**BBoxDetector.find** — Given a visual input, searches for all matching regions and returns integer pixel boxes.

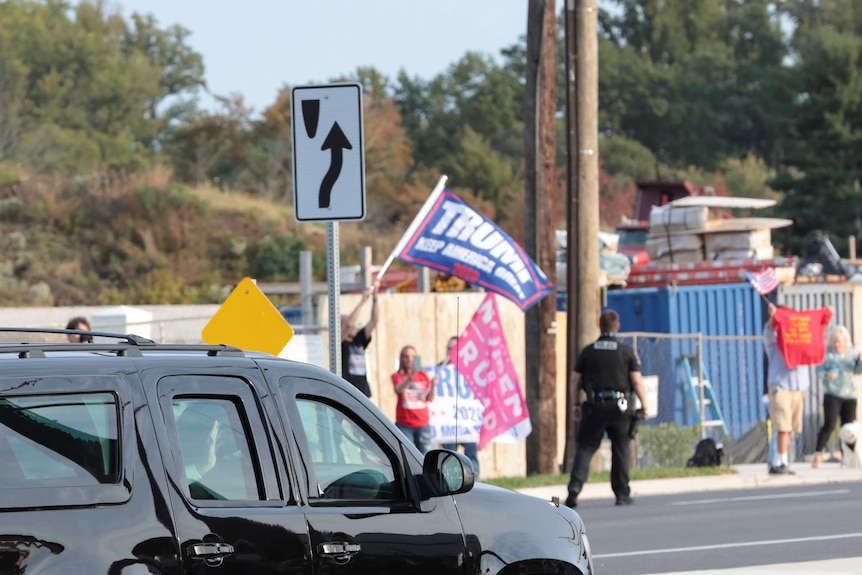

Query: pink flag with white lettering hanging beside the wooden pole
[449,293,531,449]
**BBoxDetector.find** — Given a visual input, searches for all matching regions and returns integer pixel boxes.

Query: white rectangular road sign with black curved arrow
[290,83,365,222]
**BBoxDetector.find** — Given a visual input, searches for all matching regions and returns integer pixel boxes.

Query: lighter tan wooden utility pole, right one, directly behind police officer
[564,0,600,470]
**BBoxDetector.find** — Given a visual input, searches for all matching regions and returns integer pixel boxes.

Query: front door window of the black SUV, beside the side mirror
[296,398,401,500]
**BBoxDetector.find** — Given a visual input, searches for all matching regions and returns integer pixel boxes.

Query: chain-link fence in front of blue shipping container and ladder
[619,332,822,468]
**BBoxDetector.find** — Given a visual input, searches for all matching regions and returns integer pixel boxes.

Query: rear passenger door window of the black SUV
[171,396,260,500]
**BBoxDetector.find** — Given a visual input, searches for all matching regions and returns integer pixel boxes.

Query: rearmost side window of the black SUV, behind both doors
[0,393,120,487]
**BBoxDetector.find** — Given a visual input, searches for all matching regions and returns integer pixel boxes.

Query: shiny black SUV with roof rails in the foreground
[0,328,593,575]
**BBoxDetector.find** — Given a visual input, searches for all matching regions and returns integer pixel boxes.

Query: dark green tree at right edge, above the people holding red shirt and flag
[774,24,862,254]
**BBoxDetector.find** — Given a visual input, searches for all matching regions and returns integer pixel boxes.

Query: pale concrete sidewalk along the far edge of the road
[518,461,862,502]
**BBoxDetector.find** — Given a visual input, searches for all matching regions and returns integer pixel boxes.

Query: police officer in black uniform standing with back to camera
[566,309,647,508]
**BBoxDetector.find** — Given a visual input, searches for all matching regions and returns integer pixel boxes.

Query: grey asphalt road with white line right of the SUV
[578,482,862,575]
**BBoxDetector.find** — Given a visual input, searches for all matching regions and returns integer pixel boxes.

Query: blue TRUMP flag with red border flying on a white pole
[380,177,552,311]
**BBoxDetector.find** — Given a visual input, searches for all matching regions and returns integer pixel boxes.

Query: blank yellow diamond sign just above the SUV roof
[201,278,293,355]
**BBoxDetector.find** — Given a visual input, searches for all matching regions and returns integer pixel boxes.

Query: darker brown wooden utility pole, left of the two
[524,0,558,474]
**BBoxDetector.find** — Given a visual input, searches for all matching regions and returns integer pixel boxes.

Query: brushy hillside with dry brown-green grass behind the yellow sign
[0,169,398,306]
